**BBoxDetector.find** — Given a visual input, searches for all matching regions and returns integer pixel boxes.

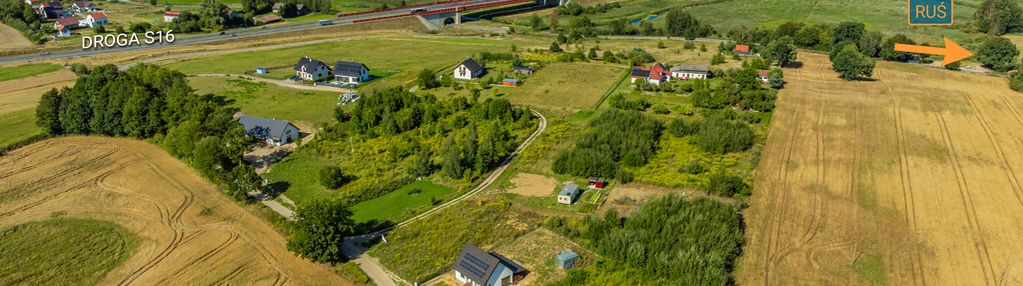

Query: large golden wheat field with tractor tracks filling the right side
[738,53,1023,285]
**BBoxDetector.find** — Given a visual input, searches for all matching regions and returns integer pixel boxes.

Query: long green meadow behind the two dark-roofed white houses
[168,38,531,88]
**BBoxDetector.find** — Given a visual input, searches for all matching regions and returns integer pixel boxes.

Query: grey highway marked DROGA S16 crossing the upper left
[0,0,527,63]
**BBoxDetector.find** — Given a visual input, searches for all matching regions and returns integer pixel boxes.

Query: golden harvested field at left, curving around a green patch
[0,137,350,285]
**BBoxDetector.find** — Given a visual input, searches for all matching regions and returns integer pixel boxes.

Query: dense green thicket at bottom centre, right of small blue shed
[559,195,743,285]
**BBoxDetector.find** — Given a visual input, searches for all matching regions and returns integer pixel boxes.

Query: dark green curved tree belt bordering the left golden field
[36,64,261,200]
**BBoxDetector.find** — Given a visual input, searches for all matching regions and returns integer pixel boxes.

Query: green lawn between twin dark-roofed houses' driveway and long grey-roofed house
[188,77,340,127]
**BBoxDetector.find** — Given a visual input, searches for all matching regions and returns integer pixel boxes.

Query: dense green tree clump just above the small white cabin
[552,108,662,182]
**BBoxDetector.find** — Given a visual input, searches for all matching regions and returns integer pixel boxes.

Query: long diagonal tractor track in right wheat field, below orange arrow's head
[935,113,994,285]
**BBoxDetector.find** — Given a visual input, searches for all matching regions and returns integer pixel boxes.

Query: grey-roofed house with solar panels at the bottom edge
[452,243,526,286]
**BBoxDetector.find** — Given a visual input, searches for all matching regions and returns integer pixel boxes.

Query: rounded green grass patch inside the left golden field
[0,219,138,285]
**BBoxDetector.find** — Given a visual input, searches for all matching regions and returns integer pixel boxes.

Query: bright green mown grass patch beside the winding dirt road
[352,181,454,223]
